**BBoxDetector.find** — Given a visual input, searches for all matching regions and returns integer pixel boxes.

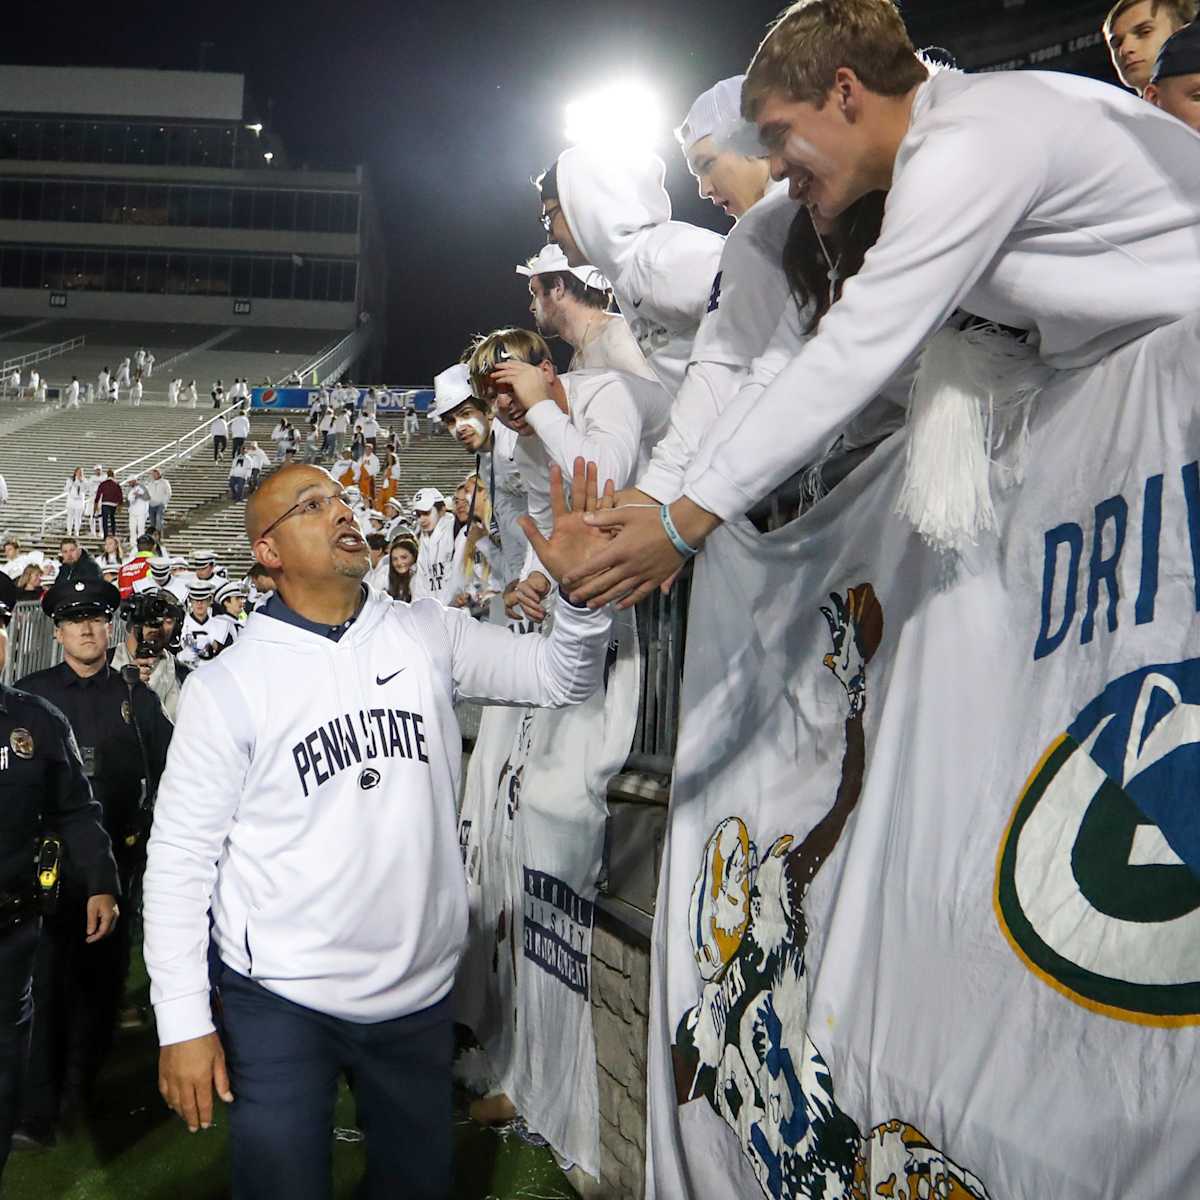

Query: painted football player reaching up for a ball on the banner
[671,583,988,1200]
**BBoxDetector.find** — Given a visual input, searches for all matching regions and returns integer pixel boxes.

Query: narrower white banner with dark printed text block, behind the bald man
[456,613,640,1176]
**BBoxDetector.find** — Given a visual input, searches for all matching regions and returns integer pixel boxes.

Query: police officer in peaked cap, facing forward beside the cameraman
[18,580,173,1142]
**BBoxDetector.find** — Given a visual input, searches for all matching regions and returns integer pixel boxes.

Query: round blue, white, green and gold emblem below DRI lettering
[995,659,1200,1026]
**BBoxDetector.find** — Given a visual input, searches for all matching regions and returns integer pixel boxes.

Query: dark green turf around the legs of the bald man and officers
[0,956,576,1200]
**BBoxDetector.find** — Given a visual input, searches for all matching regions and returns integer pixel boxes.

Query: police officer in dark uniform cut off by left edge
[0,575,118,1174]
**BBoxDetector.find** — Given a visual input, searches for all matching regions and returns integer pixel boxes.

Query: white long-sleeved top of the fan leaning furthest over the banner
[684,71,1200,520]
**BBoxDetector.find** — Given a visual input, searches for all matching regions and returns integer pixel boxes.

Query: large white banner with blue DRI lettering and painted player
[647,319,1200,1200]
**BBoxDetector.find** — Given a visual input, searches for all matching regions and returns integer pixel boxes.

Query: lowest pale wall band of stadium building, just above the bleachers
[0,285,355,331]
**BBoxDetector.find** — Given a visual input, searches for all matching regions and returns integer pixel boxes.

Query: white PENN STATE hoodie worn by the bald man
[145,588,610,1045]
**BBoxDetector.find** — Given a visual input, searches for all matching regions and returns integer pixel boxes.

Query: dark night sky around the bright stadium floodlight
[11,0,1113,383]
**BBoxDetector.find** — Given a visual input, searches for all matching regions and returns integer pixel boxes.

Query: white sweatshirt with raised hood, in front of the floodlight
[558,146,725,396]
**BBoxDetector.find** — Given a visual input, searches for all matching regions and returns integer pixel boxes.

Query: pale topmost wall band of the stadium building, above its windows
[0,66,246,121]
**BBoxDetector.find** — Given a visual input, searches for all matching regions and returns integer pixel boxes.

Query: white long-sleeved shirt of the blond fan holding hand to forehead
[516,371,671,575]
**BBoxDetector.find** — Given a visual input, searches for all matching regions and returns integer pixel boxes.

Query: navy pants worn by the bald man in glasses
[215,962,454,1200]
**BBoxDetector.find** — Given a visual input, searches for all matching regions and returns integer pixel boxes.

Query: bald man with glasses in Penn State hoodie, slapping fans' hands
[144,460,610,1200]
